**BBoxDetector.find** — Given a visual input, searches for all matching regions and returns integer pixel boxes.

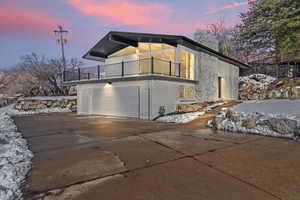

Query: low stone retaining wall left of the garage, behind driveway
[15,96,77,111]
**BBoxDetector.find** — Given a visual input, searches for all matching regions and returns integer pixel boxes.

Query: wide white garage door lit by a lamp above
[89,86,140,118]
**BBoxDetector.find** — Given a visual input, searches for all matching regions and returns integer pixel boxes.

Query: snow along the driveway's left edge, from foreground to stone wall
[0,104,70,200]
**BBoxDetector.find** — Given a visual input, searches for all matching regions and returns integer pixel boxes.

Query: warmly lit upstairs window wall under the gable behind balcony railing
[108,42,196,80]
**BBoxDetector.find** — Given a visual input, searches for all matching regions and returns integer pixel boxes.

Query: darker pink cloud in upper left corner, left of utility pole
[0,5,65,36]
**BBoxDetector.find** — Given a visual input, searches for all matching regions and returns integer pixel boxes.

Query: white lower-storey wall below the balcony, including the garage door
[77,80,195,119]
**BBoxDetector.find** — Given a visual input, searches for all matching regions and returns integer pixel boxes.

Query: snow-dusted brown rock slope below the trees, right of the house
[239,74,300,100]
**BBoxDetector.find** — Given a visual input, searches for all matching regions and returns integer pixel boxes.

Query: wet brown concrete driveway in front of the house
[15,113,300,200]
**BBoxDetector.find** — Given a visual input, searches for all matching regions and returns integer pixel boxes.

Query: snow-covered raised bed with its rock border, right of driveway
[213,99,300,139]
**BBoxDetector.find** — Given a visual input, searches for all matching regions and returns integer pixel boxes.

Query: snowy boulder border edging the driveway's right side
[208,102,300,140]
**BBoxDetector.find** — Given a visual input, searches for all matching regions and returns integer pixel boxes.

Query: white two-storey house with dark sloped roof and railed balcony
[64,32,249,119]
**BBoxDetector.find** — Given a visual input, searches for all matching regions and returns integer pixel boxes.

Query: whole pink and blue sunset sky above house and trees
[0,0,253,68]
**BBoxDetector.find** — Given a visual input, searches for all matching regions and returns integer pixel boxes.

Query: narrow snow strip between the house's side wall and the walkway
[157,102,224,124]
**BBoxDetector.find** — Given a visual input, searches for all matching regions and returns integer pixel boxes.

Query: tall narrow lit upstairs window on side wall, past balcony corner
[180,50,195,80]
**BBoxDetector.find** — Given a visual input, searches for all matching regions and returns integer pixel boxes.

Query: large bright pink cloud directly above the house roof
[66,0,204,33]
